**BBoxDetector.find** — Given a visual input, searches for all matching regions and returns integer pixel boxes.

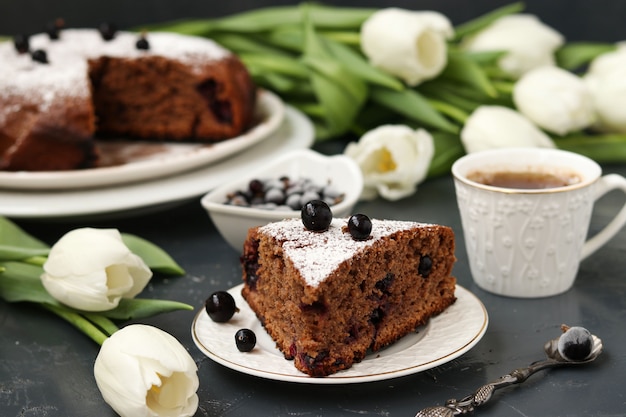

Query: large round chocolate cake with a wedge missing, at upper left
[0,29,256,171]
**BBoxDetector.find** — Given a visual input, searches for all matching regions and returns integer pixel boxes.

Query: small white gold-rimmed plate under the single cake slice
[191,284,489,384]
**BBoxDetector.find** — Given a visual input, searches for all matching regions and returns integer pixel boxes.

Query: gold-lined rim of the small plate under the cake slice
[191,284,489,385]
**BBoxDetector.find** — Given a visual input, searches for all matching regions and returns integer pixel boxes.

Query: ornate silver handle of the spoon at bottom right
[415,359,567,417]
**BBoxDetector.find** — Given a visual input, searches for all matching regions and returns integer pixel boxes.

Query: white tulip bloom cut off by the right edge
[584,47,626,133]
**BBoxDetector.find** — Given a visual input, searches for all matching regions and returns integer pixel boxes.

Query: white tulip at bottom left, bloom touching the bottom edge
[93,324,199,417]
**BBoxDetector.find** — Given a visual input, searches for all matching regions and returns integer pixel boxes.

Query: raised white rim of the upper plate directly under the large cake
[0,89,286,191]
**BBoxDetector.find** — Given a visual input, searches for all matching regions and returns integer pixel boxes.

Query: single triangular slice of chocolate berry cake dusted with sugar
[241,219,456,376]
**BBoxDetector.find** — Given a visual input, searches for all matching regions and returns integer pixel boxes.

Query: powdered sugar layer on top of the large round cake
[0,29,230,118]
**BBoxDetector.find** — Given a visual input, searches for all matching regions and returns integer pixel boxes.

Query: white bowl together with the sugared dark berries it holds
[201,149,363,251]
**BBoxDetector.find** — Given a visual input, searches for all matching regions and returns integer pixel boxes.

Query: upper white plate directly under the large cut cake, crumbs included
[0,90,285,190]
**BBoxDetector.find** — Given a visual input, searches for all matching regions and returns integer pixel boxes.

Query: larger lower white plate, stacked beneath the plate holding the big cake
[0,106,315,219]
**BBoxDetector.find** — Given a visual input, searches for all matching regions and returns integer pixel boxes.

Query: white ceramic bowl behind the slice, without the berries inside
[200,149,363,251]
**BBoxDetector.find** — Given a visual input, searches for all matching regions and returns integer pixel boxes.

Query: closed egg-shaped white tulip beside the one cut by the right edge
[513,67,594,135]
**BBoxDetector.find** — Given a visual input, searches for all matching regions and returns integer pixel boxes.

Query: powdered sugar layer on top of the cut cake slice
[260,219,430,287]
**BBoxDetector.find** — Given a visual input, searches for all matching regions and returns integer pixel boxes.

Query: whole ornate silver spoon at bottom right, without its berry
[415,326,602,417]
